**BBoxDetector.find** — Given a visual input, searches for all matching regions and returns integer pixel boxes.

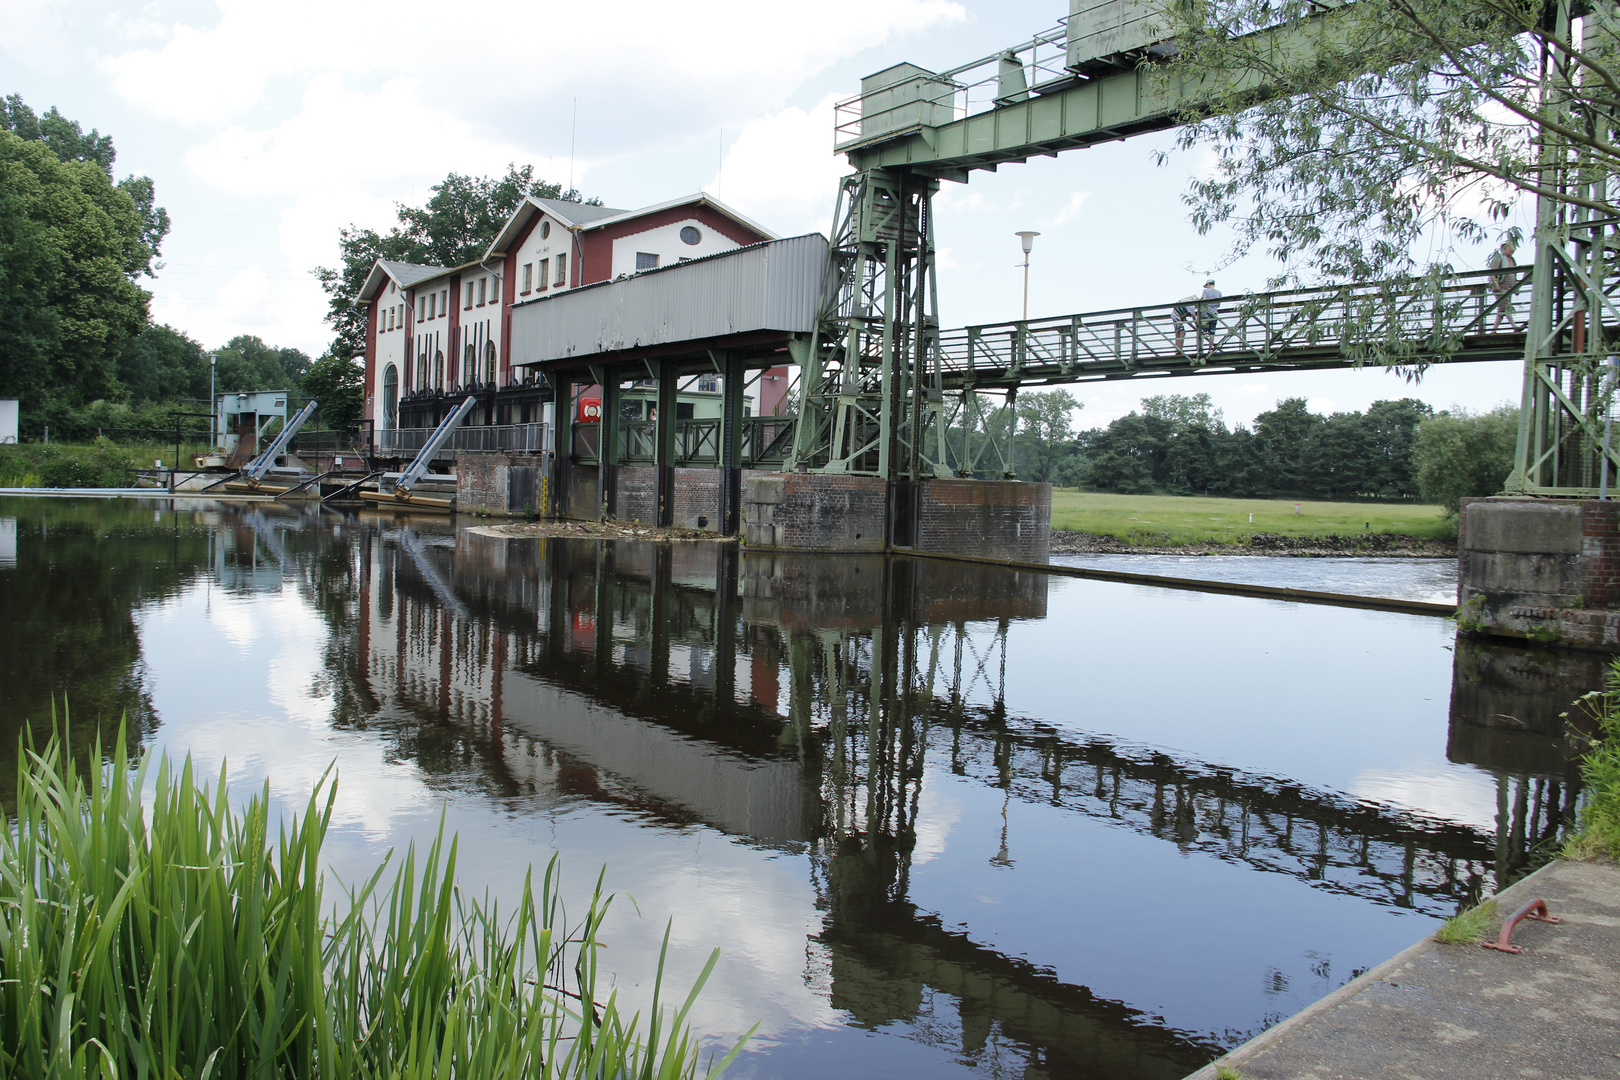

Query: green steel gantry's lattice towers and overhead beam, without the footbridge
[787,0,1620,495]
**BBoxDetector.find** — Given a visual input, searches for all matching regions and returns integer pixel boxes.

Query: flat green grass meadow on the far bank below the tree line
[1051,491,1456,544]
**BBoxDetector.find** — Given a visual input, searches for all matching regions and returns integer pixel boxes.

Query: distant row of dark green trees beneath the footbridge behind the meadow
[978,390,1518,512]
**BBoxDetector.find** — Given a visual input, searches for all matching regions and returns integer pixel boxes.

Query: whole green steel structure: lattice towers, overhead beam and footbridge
[784,0,1620,495]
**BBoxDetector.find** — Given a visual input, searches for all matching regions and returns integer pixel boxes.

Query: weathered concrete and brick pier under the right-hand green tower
[1456,497,1620,651]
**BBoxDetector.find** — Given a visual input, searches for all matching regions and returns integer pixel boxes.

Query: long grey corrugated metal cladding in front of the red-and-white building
[510,233,828,364]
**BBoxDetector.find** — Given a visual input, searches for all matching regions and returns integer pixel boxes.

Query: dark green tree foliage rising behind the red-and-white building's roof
[316,165,601,359]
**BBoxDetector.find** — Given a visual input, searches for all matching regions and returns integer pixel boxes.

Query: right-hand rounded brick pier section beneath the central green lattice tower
[917,479,1051,562]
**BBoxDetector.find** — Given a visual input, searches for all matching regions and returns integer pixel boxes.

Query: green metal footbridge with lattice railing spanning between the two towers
[938,266,1531,387]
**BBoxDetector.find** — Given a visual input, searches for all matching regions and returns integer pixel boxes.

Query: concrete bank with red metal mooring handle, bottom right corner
[1187,861,1620,1080]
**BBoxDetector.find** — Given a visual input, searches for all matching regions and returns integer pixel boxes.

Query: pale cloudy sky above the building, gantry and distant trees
[0,0,1529,427]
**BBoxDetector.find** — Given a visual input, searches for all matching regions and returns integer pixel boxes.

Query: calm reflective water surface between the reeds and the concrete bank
[0,499,1601,1080]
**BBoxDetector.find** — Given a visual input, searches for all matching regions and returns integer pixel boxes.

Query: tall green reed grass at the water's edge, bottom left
[0,725,740,1080]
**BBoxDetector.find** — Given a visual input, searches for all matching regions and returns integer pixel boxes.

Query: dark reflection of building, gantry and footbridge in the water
[335,526,1570,1078]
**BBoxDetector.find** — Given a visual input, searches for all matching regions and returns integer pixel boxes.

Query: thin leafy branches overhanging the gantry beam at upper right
[1165,0,1620,283]
